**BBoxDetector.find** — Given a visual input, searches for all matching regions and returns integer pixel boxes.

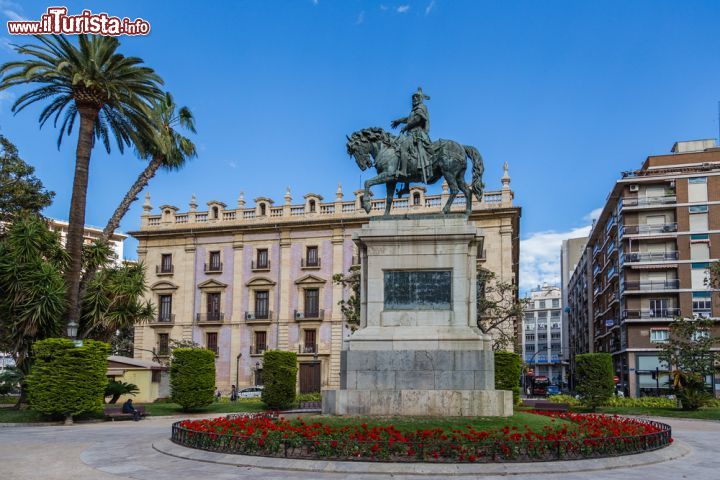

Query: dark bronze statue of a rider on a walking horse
[347,88,484,215]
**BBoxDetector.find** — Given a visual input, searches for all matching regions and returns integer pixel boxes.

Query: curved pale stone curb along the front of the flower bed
[152,439,692,476]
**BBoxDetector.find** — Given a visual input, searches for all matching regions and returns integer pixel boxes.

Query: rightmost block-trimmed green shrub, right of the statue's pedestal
[575,353,615,412]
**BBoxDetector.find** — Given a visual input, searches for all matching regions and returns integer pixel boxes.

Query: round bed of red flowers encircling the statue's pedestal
[172,412,672,462]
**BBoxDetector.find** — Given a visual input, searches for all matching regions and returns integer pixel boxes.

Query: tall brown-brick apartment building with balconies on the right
[568,140,720,397]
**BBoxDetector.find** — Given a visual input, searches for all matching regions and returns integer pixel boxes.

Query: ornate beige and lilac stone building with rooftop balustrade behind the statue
[131,166,520,394]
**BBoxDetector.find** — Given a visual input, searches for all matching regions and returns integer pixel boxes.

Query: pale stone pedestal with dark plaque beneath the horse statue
[323,215,512,416]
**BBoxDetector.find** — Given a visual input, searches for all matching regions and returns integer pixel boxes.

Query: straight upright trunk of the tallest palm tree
[65,107,98,336]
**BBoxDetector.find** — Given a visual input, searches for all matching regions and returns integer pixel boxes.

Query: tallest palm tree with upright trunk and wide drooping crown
[0,35,163,334]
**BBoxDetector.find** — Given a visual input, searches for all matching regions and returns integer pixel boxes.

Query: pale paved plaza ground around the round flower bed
[0,417,720,480]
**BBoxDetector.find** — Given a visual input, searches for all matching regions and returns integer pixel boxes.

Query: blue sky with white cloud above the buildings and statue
[0,0,720,288]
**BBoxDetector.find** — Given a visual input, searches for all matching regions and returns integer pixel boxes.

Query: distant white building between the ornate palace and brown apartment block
[522,285,566,386]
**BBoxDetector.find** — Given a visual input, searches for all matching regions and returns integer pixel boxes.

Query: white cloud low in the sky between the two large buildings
[520,215,600,292]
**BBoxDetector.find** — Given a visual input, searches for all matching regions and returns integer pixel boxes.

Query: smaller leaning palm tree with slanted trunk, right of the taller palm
[103,92,197,242]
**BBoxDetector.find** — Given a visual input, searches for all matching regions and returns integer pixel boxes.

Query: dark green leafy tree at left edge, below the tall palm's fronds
[0,135,55,222]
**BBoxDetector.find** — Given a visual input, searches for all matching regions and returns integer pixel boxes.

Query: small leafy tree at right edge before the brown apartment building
[659,317,718,410]
